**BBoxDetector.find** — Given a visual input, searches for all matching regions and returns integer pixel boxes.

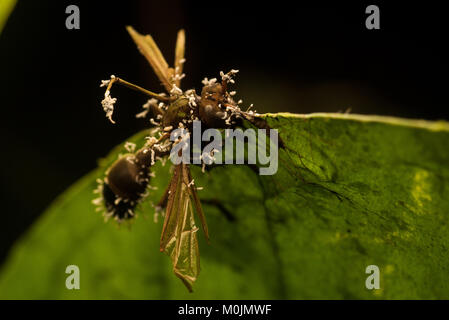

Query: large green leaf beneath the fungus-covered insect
[0,114,449,299]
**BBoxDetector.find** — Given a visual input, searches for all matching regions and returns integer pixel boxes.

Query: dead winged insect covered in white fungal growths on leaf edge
[94,26,265,291]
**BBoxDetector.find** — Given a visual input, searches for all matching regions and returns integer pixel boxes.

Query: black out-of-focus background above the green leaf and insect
[0,0,449,262]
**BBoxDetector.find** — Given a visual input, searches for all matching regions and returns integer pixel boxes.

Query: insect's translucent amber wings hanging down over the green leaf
[160,164,208,291]
